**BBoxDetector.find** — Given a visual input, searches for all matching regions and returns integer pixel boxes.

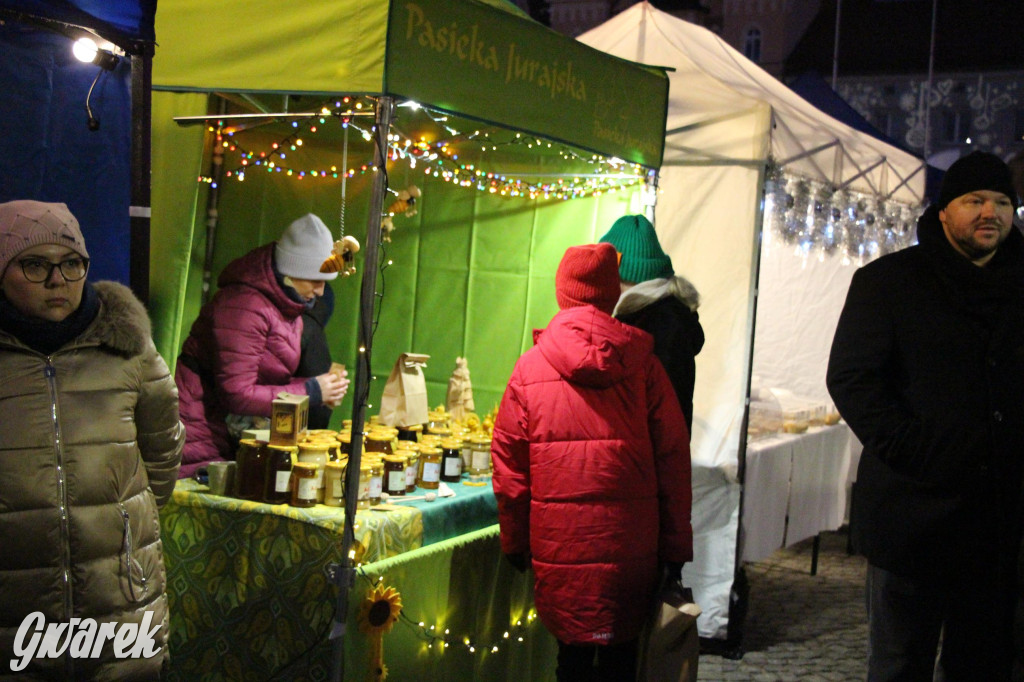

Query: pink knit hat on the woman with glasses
[0,199,89,275]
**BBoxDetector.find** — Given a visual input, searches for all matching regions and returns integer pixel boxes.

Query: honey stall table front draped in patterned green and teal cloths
[161,479,555,680]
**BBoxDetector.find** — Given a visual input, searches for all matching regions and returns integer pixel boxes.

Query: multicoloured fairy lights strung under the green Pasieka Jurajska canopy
[199,97,654,200]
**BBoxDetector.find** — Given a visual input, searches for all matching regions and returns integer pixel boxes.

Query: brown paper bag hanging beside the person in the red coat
[637,580,700,682]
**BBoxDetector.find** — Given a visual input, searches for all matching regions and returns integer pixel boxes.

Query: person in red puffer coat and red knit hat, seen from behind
[492,244,693,681]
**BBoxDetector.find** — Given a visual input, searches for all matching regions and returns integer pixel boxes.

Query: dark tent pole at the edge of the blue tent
[128,49,154,304]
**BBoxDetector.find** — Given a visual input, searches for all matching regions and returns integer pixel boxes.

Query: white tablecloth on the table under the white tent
[740,423,853,561]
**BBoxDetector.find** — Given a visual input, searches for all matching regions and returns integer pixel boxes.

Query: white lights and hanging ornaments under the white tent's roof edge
[764,160,922,266]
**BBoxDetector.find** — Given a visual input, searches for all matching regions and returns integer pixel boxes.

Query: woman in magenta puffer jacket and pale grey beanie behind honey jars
[174,213,348,477]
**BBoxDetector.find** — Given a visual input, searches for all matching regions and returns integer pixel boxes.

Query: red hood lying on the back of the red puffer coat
[534,305,654,387]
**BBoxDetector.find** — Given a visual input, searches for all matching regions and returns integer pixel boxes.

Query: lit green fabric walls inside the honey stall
[146,93,640,426]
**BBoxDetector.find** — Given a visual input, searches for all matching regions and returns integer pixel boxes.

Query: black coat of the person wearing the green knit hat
[615,296,705,433]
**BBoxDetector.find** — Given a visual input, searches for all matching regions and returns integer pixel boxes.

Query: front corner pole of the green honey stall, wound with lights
[328,95,394,682]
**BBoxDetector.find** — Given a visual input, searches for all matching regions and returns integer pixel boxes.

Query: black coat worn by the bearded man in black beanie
[827,207,1024,577]
